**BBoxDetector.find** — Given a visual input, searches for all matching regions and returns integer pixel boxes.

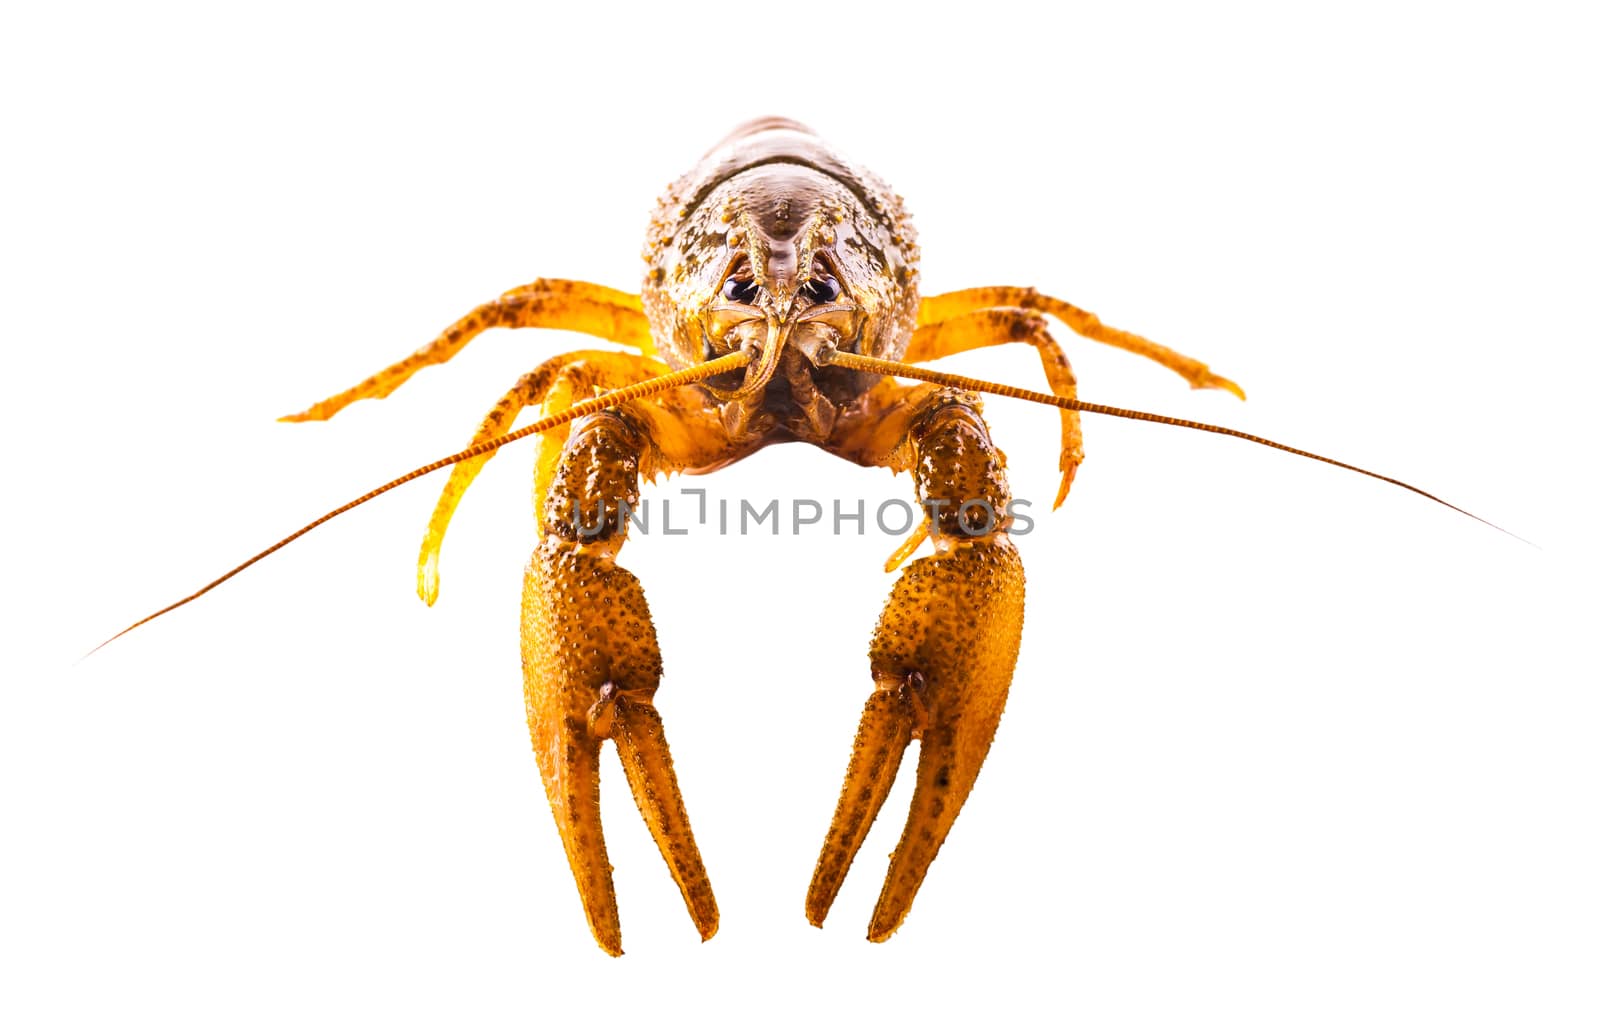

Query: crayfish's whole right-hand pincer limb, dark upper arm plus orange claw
[806,390,1022,942]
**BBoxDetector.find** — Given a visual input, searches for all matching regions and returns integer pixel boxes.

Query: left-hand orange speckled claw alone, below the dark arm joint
[522,537,717,956]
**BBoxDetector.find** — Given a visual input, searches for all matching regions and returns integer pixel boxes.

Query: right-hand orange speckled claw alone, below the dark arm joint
[806,536,1022,942]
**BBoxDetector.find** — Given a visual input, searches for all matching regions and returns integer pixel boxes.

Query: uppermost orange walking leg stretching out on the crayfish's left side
[282,278,654,422]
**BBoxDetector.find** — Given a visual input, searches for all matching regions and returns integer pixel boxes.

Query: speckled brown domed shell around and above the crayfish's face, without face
[642,118,918,369]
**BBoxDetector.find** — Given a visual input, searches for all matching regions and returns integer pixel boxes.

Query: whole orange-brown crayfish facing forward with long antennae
[103,118,1497,955]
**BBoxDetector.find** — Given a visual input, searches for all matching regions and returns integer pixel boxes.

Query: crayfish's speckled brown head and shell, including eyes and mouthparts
[643,118,917,440]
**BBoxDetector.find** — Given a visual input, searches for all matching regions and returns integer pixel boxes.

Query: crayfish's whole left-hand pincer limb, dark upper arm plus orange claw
[522,409,717,955]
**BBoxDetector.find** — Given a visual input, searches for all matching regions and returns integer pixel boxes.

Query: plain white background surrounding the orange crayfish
[0,3,1600,1022]
